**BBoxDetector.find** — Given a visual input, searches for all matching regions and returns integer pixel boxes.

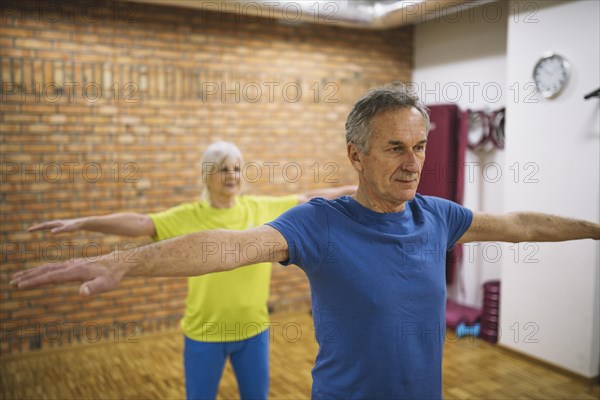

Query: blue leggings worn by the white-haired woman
[183,329,269,400]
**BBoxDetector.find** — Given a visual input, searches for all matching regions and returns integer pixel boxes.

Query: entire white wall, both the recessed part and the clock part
[413,0,600,377]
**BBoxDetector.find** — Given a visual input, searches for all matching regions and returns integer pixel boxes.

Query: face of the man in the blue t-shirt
[348,108,427,210]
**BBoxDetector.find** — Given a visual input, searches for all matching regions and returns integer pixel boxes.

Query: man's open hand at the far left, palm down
[10,253,127,296]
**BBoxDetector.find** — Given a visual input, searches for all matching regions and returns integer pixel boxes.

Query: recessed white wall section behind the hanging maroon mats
[413,1,508,307]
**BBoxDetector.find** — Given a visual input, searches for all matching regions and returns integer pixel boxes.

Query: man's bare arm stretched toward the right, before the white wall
[458,212,600,243]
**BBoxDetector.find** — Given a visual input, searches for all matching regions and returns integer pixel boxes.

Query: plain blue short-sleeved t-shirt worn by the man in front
[268,194,473,399]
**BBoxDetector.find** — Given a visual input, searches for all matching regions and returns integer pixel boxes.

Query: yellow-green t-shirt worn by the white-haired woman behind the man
[150,195,298,342]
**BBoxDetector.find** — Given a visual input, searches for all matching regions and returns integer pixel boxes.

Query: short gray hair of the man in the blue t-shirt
[346,82,429,154]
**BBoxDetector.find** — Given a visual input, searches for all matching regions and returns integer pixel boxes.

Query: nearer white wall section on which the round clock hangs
[500,0,600,377]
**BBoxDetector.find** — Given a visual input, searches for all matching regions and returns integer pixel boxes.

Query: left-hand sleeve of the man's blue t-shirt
[267,199,329,271]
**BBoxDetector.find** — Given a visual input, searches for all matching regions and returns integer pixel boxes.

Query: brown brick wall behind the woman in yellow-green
[0,1,412,354]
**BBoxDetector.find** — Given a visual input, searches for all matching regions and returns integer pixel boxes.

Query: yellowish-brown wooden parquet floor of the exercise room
[0,314,600,399]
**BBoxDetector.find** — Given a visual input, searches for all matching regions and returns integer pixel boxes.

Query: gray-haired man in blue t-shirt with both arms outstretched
[11,84,600,399]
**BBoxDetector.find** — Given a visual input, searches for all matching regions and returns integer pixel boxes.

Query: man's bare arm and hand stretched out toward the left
[11,225,288,296]
